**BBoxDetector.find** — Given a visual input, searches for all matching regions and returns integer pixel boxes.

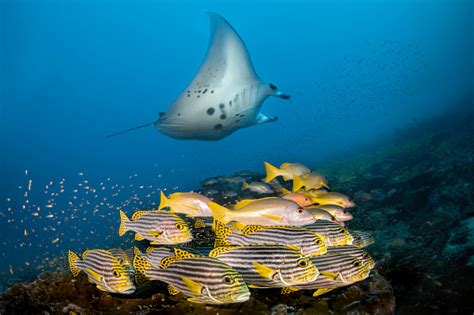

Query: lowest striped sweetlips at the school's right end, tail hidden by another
[282,250,372,296]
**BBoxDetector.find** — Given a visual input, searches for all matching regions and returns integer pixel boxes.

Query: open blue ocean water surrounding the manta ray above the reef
[0,0,474,292]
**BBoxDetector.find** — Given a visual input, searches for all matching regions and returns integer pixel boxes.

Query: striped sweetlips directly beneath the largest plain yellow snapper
[214,221,326,257]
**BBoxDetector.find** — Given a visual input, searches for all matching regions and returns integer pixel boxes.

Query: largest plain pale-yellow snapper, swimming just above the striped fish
[209,197,315,226]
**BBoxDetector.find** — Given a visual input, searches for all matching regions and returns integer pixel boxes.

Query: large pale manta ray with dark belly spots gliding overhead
[108,12,290,141]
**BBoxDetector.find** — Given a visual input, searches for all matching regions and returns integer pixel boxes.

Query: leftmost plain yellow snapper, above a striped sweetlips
[158,191,212,217]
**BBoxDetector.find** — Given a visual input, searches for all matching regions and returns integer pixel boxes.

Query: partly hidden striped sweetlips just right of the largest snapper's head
[304,220,354,246]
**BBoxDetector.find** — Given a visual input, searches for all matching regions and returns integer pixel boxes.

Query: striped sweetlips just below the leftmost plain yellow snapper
[119,210,193,245]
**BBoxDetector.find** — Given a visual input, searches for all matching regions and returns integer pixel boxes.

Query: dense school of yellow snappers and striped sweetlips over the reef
[68,162,375,304]
